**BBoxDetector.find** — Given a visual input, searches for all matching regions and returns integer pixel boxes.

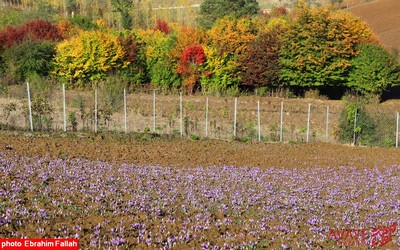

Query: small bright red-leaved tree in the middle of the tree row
[178,44,206,94]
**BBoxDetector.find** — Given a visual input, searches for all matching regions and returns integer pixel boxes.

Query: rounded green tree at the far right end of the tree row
[347,43,400,96]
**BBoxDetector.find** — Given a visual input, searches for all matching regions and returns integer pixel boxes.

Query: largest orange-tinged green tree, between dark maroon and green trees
[280,2,374,95]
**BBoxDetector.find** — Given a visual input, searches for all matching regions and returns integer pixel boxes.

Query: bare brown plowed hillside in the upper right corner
[348,0,400,56]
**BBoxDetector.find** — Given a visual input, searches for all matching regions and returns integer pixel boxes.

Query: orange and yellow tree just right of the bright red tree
[201,16,260,93]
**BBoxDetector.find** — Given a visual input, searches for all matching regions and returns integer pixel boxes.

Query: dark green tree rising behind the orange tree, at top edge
[197,0,260,29]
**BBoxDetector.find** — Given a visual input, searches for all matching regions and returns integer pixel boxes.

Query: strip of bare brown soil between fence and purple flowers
[0,133,400,168]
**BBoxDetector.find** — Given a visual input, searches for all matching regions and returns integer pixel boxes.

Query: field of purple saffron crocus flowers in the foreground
[0,145,400,249]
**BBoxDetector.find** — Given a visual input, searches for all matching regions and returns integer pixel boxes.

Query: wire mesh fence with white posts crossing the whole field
[0,84,399,147]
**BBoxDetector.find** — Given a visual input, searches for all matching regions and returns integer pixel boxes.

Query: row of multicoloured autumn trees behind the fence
[0,0,400,98]
